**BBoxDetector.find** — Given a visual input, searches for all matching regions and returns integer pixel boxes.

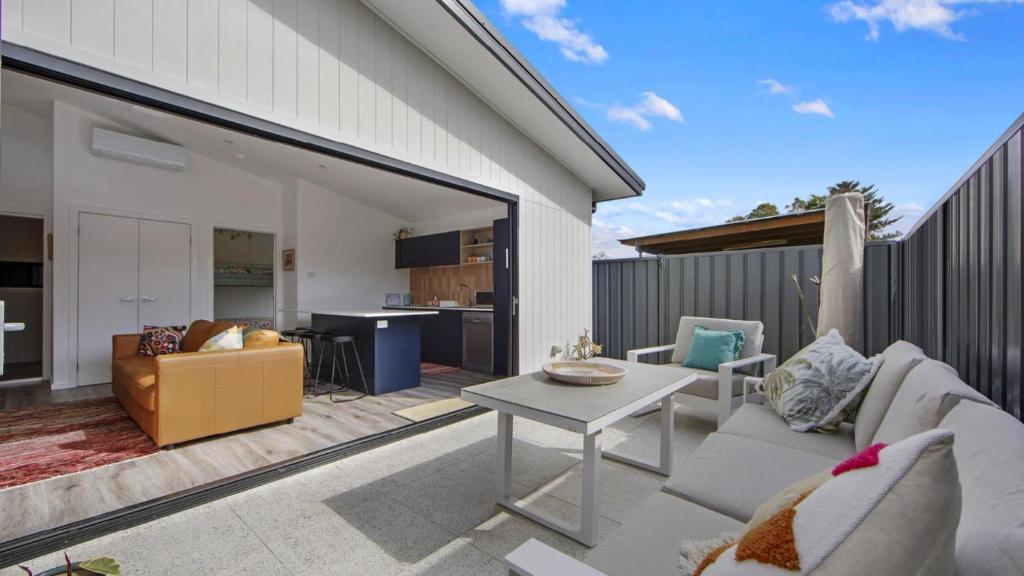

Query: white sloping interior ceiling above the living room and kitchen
[2,71,504,222]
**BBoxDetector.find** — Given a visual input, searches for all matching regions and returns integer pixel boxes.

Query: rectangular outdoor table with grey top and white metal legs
[462,359,697,546]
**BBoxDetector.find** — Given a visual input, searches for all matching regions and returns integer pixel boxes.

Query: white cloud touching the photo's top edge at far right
[828,0,1024,41]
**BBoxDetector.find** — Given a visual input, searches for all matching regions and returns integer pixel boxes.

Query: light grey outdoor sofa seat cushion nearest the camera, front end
[584,492,743,576]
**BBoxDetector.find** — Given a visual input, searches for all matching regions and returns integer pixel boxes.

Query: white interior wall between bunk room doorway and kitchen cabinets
[286,179,410,311]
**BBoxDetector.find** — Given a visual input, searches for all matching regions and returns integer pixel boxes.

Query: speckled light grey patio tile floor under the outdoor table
[0,407,712,576]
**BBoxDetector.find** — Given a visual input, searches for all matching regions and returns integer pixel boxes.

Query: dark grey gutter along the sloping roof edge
[435,0,647,196]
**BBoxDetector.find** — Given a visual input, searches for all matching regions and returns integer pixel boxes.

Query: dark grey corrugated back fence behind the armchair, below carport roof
[593,242,898,361]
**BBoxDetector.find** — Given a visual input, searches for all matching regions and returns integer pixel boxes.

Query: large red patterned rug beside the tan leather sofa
[0,398,160,489]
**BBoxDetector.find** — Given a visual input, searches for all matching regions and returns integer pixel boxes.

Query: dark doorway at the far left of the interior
[0,214,46,385]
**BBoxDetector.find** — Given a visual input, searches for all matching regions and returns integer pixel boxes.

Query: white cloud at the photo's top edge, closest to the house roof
[502,0,608,64]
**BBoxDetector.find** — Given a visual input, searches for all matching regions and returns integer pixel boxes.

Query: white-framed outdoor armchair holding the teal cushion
[626,316,775,426]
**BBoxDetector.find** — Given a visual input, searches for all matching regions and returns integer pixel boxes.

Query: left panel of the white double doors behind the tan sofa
[78,212,139,386]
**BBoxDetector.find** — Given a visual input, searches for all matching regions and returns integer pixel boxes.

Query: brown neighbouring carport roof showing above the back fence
[618,209,825,254]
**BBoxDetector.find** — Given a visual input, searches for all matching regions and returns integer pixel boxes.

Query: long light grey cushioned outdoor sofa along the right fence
[506,341,1024,576]
